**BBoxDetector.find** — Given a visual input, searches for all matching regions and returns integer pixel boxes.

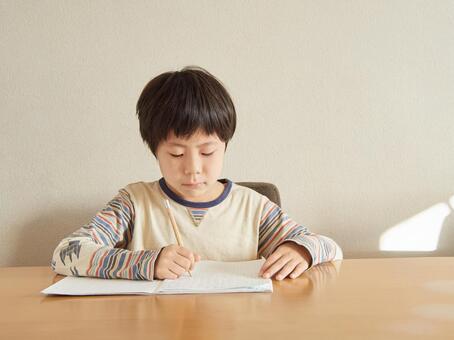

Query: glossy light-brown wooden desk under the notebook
[0,257,454,340]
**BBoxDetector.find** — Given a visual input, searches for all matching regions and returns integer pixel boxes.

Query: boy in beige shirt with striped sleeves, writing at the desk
[51,67,342,280]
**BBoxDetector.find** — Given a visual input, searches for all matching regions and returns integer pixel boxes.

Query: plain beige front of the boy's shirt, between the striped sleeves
[125,181,267,261]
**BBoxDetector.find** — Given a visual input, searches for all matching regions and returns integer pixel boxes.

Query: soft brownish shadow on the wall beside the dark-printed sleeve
[2,209,94,266]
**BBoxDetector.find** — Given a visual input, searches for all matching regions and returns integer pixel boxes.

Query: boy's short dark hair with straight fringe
[136,66,236,156]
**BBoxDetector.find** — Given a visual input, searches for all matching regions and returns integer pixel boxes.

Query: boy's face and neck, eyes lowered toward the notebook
[156,131,225,202]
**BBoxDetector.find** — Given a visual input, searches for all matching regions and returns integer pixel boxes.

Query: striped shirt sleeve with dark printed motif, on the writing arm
[51,189,159,280]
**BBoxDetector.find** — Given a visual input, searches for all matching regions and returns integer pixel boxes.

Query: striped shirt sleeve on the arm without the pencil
[258,200,343,266]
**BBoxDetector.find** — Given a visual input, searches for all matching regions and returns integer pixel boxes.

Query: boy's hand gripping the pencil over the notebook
[154,244,200,280]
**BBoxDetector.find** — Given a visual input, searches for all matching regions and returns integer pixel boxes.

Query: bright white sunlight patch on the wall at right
[380,203,454,251]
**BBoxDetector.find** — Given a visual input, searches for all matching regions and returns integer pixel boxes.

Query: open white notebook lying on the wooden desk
[41,259,273,295]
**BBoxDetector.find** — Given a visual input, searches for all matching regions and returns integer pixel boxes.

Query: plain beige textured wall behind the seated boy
[0,0,454,266]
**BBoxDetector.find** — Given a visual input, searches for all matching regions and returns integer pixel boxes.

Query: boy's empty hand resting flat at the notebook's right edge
[259,242,312,280]
